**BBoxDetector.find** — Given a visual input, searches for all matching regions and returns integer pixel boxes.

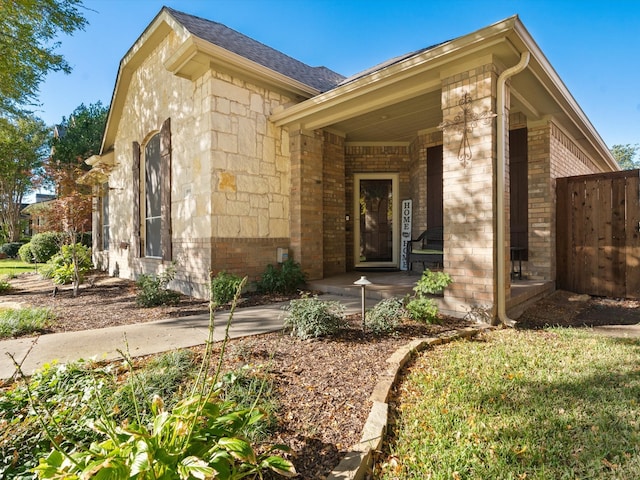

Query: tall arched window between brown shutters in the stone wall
[144,134,162,257]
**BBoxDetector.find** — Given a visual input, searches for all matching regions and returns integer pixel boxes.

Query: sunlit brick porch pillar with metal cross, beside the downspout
[442,64,500,316]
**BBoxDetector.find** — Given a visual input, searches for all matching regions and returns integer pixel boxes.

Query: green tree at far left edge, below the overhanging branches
[0,116,49,242]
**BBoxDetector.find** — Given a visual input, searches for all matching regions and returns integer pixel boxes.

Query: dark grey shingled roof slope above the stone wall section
[163,7,345,92]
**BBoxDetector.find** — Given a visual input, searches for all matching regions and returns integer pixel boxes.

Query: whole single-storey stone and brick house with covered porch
[86,8,618,317]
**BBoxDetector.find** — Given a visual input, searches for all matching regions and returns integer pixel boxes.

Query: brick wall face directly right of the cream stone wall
[289,130,323,280]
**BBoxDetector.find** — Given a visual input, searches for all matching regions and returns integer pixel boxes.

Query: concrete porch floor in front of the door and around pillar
[308,271,555,319]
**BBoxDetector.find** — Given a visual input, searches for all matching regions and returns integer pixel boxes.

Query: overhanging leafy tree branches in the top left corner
[0,0,87,115]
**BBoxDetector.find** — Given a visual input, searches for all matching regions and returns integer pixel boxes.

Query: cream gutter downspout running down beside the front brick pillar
[496,52,531,327]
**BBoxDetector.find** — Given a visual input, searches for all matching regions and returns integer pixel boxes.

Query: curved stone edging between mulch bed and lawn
[327,326,491,480]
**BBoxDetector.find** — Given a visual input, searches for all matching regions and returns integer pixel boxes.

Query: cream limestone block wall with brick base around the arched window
[108,32,291,296]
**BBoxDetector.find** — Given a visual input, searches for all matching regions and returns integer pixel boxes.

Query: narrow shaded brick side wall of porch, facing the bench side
[322,132,348,277]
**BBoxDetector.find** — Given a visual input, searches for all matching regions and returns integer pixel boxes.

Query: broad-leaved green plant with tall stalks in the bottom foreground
[35,278,295,480]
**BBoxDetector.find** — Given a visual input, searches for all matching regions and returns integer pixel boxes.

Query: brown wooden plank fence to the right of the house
[556,170,640,298]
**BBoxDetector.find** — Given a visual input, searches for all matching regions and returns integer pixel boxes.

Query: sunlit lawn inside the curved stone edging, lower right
[375,329,640,480]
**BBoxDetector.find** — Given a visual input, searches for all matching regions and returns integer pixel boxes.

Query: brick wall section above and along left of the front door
[344,145,411,270]
